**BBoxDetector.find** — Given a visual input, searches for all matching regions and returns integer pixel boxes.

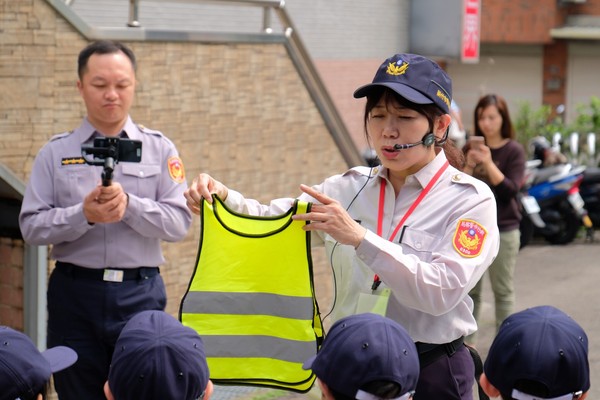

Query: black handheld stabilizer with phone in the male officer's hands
[81,137,142,186]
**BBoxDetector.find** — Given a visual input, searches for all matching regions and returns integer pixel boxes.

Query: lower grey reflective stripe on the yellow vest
[202,335,317,363]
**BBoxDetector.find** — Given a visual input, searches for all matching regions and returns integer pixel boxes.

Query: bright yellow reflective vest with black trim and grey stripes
[180,196,323,393]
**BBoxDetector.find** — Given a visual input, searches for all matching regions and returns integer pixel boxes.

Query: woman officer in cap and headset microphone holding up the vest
[185,54,498,400]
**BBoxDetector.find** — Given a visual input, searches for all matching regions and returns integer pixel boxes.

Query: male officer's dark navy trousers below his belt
[48,267,166,400]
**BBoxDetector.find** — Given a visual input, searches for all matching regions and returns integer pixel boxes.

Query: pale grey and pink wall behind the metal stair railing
[64,0,412,153]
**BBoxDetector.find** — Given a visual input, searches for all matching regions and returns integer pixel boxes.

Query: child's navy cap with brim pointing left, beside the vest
[303,313,419,399]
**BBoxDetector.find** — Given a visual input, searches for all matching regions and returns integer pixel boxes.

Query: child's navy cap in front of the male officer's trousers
[108,310,209,400]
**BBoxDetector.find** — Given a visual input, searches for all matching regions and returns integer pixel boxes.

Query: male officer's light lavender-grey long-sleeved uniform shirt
[19,118,192,268]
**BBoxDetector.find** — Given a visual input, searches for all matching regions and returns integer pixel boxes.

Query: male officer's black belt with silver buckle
[56,261,160,282]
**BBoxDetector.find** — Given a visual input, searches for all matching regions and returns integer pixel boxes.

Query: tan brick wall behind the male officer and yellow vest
[0,0,347,327]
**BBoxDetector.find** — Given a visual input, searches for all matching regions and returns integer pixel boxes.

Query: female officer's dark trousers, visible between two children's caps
[414,345,475,400]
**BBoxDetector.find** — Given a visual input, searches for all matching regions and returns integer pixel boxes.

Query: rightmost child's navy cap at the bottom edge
[483,306,590,400]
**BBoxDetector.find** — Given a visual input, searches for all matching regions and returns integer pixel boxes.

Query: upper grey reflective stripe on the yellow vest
[182,291,313,320]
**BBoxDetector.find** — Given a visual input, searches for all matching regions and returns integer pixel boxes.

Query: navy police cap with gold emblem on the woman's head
[354,54,452,114]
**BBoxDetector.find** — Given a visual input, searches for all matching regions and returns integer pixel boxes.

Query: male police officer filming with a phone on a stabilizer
[19,41,191,400]
